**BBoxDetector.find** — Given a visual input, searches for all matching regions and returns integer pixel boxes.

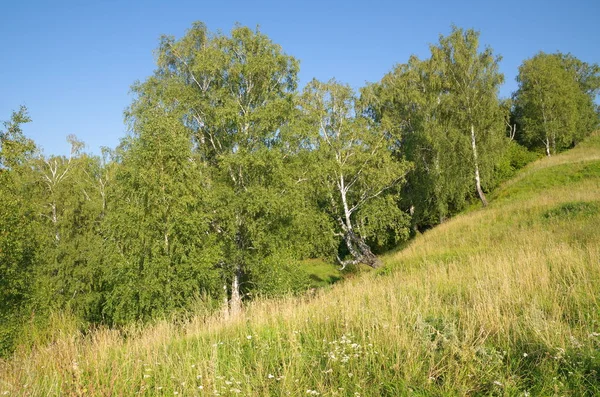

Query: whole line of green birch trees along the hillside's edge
[0,23,600,354]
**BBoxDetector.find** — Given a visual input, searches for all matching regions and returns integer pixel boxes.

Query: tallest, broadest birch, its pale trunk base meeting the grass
[129,23,328,315]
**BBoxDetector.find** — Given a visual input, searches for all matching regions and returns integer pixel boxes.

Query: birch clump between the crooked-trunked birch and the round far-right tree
[362,28,508,228]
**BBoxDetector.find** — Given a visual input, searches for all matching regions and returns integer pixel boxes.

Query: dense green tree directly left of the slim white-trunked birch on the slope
[362,56,472,229]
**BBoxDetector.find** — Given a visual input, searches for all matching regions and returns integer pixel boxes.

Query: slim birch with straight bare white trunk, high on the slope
[430,27,506,206]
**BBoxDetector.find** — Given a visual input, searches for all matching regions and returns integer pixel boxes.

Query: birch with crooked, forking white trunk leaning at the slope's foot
[298,80,408,268]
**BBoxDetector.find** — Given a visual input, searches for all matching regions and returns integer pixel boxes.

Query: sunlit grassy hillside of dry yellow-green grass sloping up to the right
[0,135,600,396]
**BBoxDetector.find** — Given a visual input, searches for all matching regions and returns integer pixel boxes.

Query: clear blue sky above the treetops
[0,0,600,154]
